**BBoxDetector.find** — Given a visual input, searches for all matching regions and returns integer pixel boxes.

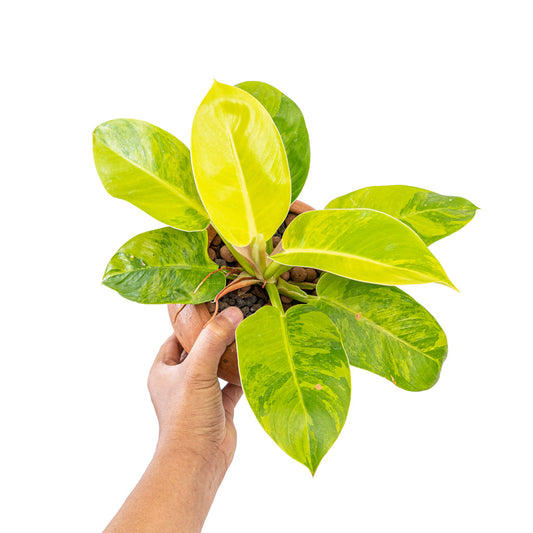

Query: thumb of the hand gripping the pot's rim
[182,307,243,379]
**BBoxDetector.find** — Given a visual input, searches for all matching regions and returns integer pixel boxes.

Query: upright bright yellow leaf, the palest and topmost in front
[191,81,291,247]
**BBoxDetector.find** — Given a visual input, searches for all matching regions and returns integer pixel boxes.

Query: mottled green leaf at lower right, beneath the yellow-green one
[312,274,448,391]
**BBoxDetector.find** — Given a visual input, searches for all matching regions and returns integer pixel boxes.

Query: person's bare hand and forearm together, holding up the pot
[104,307,242,533]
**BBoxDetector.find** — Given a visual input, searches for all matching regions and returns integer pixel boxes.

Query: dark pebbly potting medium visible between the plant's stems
[206,213,321,318]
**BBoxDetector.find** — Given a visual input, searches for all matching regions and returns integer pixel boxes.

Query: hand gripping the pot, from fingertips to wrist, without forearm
[148,307,243,483]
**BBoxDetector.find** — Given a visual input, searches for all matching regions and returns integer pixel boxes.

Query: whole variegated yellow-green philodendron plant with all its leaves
[94,82,476,473]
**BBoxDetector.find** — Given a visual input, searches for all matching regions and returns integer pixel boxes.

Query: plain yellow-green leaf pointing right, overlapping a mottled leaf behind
[272,209,455,288]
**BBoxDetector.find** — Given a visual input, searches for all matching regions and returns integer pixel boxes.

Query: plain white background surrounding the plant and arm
[0,0,533,533]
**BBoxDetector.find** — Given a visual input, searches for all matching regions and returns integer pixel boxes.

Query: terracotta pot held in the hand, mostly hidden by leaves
[168,200,313,385]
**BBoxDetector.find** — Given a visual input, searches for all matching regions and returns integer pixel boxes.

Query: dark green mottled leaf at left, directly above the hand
[103,228,226,304]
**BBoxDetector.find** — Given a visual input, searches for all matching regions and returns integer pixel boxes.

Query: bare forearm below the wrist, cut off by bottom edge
[104,449,224,533]
